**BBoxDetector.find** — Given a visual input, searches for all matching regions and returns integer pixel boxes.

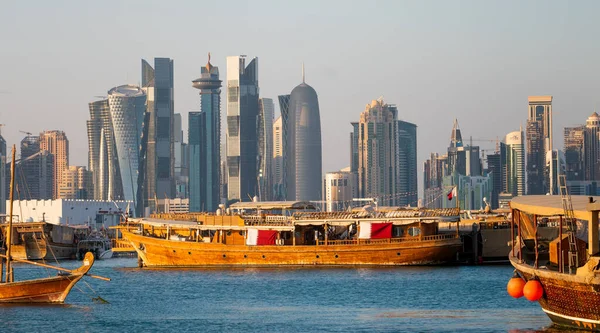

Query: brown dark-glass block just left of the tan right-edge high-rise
[564,126,587,182]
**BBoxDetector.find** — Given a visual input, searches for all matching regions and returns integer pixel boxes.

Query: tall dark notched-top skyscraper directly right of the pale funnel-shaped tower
[142,58,175,205]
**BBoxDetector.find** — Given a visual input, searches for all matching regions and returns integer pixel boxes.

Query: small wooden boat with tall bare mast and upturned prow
[0,145,110,303]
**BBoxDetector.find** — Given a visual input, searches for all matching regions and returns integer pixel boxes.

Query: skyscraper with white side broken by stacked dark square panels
[226,56,259,201]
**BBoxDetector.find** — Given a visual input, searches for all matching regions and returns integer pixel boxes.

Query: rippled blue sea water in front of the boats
[0,258,580,332]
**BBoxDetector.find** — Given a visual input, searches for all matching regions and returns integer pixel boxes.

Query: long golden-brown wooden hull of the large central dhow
[123,231,462,268]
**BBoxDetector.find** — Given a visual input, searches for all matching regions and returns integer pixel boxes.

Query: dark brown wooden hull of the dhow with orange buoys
[510,257,600,331]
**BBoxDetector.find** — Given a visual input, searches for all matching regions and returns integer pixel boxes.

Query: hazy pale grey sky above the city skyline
[0,0,600,193]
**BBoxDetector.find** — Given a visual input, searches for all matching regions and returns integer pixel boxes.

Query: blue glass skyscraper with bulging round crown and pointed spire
[188,54,221,212]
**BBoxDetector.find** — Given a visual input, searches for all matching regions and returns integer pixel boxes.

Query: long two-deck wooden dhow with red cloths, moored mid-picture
[120,202,462,267]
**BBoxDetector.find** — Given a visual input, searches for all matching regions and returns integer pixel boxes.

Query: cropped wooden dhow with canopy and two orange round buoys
[507,186,600,331]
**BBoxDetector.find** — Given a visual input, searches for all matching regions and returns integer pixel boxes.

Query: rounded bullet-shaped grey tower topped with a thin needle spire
[285,69,322,201]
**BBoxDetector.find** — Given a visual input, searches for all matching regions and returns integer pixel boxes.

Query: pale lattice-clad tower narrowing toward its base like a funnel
[108,85,146,204]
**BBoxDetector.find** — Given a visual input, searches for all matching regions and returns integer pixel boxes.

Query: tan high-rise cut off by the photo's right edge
[583,112,600,180]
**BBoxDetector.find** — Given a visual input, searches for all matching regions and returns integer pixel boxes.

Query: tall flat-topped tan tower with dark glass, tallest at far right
[526,96,553,194]
